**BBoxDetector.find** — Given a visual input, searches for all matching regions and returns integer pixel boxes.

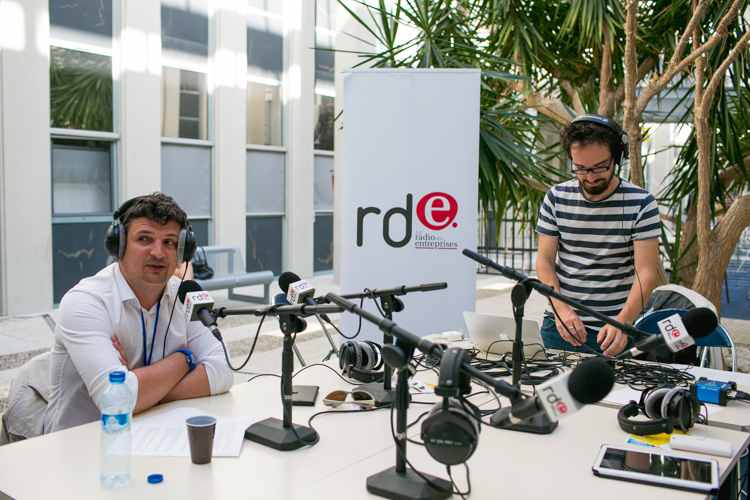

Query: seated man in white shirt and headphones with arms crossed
[44,193,234,434]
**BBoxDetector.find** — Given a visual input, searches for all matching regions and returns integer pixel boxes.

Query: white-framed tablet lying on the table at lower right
[592,444,719,493]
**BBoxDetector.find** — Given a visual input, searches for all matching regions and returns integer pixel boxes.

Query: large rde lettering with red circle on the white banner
[357,192,458,248]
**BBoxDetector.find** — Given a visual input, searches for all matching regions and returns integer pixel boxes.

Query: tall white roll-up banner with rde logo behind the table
[341,69,480,343]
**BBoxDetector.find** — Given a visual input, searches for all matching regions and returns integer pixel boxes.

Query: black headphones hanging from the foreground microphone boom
[422,347,482,465]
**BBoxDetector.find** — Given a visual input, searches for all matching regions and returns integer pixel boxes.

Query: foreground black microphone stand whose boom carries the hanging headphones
[326,293,544,500]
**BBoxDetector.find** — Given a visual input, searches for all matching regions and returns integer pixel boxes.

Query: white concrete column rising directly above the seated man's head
[113,0,161,199]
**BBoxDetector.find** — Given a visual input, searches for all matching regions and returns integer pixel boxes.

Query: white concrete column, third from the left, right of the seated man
[210,0,247,250]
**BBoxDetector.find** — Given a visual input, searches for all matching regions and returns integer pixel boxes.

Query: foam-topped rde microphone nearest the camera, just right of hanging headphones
[500,358,615,427]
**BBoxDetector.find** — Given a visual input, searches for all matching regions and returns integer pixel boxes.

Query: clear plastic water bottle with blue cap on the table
[99,371,133,488]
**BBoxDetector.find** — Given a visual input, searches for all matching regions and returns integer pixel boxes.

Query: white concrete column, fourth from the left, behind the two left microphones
[284,0,315,277]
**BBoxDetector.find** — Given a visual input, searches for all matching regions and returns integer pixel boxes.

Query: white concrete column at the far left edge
[0,0,52,316]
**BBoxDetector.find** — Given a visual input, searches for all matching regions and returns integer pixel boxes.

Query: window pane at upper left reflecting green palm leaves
[50,47,112,132]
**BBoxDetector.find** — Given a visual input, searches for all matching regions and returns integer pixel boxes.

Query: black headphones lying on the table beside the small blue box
[617,387,701,436]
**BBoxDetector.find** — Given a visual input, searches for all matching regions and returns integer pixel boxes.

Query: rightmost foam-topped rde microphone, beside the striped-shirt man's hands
[617,307,719,359]
